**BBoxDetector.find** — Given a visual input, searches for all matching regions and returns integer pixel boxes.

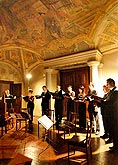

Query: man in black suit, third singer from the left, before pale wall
[36,85,51,116]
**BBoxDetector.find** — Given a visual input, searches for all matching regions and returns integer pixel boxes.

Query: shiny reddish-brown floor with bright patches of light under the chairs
[0,118,118,165]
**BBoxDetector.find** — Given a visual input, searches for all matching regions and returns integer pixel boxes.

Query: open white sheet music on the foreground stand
[38,115,53,130]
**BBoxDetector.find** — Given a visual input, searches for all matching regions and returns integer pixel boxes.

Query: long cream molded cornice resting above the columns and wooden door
[44,50,102,69]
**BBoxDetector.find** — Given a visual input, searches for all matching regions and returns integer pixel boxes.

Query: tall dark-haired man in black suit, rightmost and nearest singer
[103,78,118,152]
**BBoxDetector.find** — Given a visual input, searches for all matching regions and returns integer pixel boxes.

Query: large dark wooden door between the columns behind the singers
[60,67,90,116]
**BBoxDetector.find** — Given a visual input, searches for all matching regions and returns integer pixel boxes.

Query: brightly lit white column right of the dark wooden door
[88,61,100,87]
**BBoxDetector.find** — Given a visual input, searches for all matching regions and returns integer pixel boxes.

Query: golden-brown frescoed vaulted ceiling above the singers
[0,0,118,73]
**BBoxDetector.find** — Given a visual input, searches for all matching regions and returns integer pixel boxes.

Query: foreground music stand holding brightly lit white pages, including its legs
[38,115,57,155]
